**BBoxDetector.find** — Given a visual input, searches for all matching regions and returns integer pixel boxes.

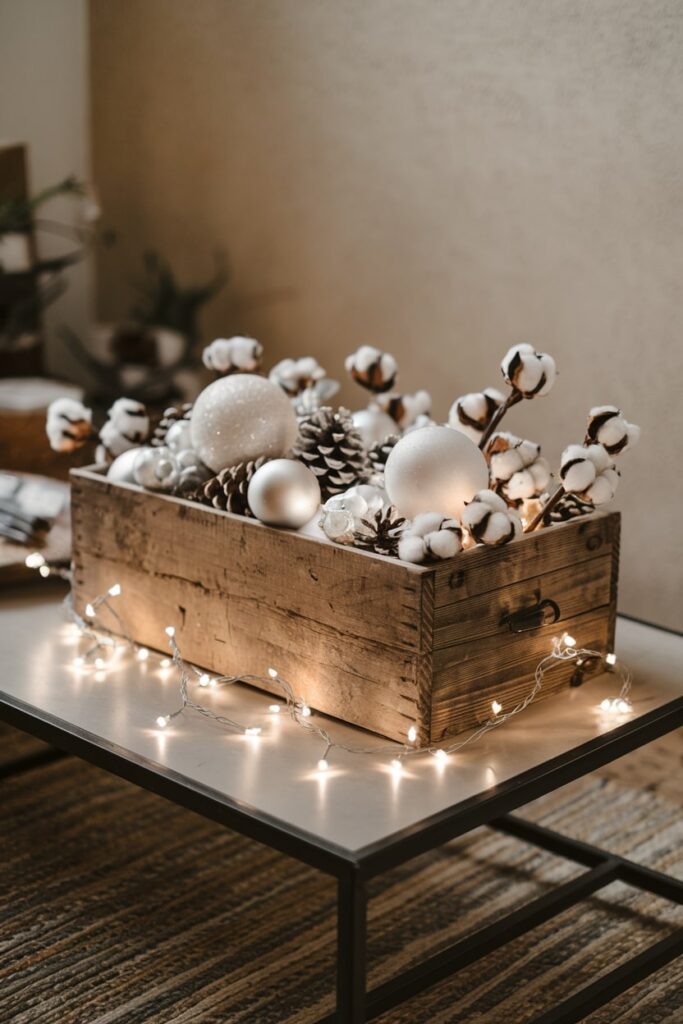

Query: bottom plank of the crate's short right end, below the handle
[431,605,610,742]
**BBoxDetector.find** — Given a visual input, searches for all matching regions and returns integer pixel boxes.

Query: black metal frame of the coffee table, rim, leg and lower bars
[0,693,683,1024]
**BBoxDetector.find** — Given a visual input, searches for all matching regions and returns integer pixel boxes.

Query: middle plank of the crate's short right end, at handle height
[434,549,612,649]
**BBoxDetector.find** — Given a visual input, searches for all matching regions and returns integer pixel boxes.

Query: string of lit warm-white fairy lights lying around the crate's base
[26,553,633,774]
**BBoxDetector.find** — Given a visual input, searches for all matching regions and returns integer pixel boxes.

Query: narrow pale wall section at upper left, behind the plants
[0,0,91,377]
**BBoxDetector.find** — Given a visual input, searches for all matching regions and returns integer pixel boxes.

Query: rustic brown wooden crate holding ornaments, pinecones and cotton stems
[72,469,620,742]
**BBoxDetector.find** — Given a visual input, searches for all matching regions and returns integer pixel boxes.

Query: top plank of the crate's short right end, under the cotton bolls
[434,512,620,608]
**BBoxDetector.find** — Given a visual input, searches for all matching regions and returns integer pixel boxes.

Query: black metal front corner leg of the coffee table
[337,871,368,1024]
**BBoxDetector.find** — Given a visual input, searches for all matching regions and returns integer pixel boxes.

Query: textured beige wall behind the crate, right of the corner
[91,0,683,626]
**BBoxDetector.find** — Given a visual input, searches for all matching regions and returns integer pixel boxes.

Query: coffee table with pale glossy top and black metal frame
[0,590,683,1024]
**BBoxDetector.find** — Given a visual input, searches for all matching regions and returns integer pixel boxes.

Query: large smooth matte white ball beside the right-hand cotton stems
[384,426,488,519]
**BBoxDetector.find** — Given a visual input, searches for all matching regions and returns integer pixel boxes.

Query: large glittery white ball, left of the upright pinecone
[190,374,299,473]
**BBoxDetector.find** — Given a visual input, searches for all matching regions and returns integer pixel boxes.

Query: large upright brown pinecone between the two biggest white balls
[294,407,366,503]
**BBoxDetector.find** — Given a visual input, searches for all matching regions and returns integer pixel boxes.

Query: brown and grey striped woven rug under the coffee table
[0,730,683,1024]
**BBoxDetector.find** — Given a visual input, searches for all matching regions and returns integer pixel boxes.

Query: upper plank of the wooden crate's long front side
[72,472,431,653]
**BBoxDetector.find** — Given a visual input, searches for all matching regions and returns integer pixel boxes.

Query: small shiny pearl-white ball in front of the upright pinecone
[247,459,321,529]
